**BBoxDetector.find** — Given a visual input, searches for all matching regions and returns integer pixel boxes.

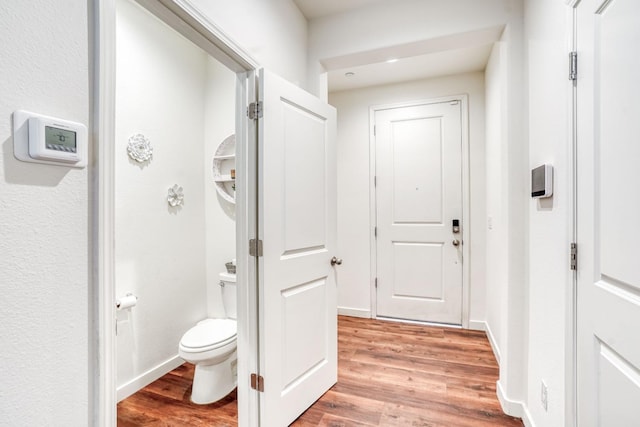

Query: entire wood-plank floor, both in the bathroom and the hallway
[118,316,522,427]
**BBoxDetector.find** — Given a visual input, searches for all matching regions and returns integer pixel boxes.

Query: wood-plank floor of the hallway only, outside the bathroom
[292,317,522,427]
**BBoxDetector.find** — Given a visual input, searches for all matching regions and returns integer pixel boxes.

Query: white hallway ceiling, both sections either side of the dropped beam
[293,0,503,92]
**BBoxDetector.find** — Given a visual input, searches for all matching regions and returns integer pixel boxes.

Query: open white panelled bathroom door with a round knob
[258,71,337,426]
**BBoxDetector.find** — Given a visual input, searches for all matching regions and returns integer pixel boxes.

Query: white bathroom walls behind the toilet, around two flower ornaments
[115,0,235,399]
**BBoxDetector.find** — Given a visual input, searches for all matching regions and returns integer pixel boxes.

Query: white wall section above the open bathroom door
[189,0,309,90]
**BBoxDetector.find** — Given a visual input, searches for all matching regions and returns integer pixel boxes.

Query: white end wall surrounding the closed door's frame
[329,73,486,325]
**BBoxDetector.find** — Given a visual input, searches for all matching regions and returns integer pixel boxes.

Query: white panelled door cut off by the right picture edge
[577,0,640,427]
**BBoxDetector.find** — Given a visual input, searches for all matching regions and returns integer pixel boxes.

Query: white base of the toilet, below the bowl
[191,351,238,405]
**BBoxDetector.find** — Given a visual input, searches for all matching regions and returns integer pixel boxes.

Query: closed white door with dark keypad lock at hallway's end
[375,100,464,325]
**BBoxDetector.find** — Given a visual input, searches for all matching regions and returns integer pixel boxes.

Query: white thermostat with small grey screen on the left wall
[13,110,87,168]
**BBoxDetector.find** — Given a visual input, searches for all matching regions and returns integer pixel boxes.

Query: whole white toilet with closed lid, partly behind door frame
[178,273,238,405]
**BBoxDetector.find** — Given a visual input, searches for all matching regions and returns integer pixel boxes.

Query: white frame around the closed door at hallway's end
[369,94,471,329]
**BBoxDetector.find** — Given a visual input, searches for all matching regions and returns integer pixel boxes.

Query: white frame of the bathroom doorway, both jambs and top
[89,0,259,427]
